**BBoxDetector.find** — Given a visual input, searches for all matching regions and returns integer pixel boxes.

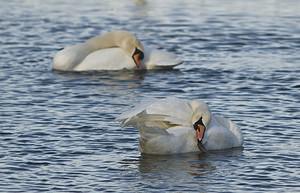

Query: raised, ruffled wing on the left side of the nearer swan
[117,97,193,129]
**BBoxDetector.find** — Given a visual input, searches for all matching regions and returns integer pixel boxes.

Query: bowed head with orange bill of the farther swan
[121,35,144,69]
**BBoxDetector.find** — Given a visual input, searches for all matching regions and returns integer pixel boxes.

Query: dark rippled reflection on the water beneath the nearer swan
[138,147,243,178]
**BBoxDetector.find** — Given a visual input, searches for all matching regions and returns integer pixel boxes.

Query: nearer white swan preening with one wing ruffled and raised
[117,97,243,154]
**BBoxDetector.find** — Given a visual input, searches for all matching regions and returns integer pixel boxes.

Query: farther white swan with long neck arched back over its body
[53,31,182,71]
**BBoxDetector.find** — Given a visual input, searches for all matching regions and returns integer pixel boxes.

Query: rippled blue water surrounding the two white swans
[0,0,300,192]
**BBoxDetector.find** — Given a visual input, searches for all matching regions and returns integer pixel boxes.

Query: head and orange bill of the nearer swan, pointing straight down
[190,101,211,152]
